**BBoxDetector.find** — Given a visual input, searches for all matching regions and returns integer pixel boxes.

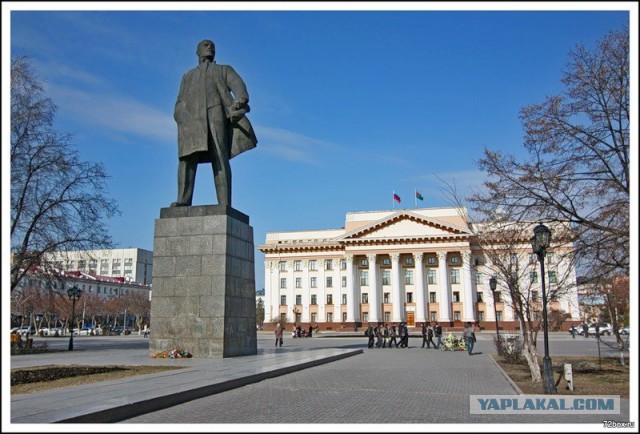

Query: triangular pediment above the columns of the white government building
[338,211,472,241]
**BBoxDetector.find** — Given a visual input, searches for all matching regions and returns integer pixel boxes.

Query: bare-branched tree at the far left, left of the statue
[11,57,119,292]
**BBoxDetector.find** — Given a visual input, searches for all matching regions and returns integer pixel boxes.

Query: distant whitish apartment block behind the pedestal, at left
[44,248,153,285]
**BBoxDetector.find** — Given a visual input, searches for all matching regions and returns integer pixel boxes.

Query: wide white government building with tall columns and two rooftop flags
[258,207,579,330]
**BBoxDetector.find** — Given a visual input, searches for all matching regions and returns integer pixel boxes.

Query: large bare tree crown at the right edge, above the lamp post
[470,27,630,278]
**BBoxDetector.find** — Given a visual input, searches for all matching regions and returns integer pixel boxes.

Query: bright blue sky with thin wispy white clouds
[2,2,637,294]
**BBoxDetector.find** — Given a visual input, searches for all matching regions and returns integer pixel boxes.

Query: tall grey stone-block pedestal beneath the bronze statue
[149,205,258,358]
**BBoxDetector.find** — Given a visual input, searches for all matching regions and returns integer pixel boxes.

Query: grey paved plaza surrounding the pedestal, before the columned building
[11,332,629,431]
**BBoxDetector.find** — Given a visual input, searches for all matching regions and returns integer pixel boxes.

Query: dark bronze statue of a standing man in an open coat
[171,39,258,207]
